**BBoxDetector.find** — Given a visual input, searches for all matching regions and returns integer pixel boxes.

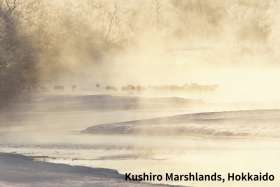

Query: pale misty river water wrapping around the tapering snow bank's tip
[0,99,280,187]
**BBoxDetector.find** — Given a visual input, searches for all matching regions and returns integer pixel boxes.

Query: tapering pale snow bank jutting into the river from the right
[82,110,280,138]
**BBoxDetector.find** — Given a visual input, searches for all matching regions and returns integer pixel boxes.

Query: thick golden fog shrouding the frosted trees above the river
[0,0,279,104]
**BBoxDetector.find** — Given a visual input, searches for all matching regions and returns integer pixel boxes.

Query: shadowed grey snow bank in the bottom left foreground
[0,153,176,187]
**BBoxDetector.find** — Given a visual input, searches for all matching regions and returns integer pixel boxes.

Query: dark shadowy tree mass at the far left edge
[0,0,37,109]
